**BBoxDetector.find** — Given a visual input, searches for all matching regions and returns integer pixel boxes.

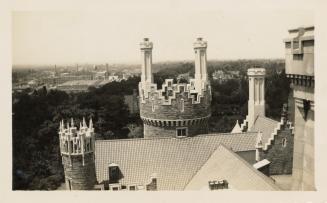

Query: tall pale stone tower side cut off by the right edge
[284,26,315,190]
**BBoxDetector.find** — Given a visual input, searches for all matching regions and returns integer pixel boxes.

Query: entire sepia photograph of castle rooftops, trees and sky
[1,0,327,201]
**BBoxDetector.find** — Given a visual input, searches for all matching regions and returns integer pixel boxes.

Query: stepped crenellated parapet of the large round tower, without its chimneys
[139,79,211,121]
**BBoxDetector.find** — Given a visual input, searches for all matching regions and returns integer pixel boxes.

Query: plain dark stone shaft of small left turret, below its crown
[62,153,96,190]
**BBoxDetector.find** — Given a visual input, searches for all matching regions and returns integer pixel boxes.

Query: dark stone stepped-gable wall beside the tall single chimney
[259,124,294,175]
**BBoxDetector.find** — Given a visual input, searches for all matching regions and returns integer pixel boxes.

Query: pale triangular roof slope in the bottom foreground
[185,145,279,190]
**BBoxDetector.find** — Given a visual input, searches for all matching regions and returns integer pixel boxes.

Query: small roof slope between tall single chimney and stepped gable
[249,116,278,145]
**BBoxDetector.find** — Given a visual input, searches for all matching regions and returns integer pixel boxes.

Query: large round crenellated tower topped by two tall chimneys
[139,38,211,138]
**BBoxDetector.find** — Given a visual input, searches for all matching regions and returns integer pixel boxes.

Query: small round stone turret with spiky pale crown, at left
[59,118,96,190]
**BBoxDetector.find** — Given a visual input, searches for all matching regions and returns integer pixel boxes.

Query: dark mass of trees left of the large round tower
[13,77,139,190]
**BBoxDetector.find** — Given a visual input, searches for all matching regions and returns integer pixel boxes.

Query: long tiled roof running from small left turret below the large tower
[95,132,257,190]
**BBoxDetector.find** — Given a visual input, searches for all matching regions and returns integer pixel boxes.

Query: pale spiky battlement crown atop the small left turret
[59,118,94,156]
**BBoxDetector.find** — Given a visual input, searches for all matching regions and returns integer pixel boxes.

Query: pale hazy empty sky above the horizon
[12,8,314,65]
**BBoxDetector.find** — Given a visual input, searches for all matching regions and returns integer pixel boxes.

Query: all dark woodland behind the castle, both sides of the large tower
[12,60,289,190]
